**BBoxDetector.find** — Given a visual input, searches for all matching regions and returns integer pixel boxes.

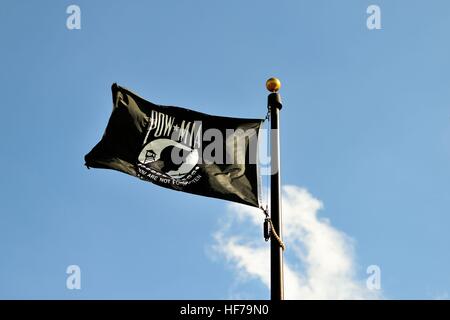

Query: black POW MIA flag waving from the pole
[85,84,263,207]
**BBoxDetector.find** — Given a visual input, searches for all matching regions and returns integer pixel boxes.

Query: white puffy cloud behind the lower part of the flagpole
[213,186,381,299]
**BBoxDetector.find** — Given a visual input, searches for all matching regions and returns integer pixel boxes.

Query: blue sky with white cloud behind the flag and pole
[0,0,450,299]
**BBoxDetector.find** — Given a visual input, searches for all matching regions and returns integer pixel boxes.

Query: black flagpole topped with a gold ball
[266,78,284,301]
